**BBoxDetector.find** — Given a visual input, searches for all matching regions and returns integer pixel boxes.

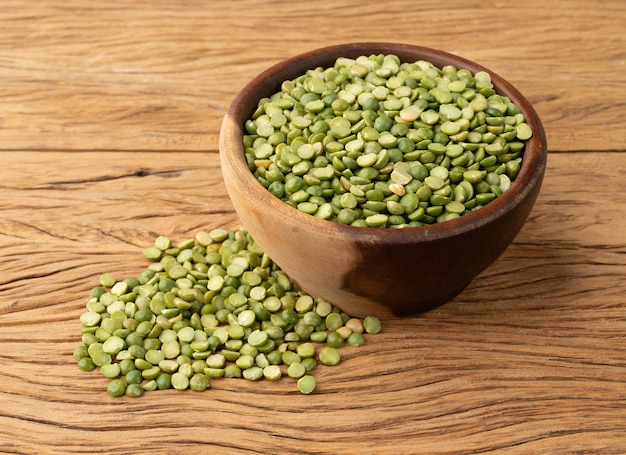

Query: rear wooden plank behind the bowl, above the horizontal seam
[0,0,626,151]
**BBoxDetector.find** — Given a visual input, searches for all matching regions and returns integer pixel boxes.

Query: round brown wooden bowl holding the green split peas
[220,43,547,318]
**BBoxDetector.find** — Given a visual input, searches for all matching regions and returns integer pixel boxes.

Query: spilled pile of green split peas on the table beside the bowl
[74,229,380,397]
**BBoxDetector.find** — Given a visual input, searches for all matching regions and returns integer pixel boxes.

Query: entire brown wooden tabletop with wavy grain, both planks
[0,0,626,454]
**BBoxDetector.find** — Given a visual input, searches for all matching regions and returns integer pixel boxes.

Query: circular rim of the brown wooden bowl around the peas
[219,42,547,244]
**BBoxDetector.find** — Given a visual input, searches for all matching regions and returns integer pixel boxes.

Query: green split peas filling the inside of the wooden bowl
[243,54,532,227]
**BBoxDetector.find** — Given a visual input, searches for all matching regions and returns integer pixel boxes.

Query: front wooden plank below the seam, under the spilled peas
[0,152,626,454]
